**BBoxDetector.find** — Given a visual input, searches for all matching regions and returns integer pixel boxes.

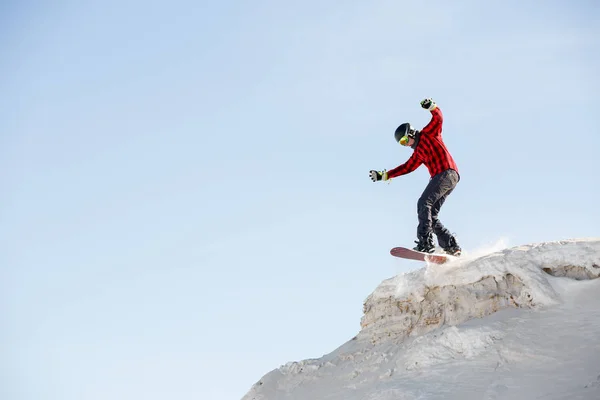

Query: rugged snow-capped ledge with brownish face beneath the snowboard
[359,240,600,342]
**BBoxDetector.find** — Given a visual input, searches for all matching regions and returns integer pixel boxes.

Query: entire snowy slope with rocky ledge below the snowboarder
[242,239,600,400]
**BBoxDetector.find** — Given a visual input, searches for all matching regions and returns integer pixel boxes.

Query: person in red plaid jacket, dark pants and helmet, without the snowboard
[369,98,461,256]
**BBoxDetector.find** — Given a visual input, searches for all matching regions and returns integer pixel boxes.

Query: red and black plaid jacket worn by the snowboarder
[388,107,458,178]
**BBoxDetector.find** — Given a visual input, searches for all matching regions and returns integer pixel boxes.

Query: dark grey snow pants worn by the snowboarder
[417,169,460,248]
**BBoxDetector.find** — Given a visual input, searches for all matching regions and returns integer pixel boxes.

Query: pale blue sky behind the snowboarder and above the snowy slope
[0,0,600,400]
